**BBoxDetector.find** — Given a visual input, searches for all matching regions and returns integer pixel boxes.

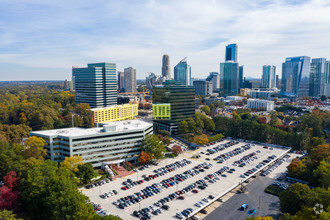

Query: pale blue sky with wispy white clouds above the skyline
[0,0,330,81]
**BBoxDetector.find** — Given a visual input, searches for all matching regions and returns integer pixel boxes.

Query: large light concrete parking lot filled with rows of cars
[82,140,289,219]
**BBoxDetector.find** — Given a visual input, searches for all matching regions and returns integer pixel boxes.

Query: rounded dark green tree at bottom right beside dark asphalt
[280,183,315,215]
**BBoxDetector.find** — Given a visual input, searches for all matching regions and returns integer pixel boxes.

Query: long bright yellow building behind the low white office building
[91,102,138,125]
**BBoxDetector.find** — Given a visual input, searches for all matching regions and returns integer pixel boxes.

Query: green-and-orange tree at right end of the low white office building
[141,134,165,159]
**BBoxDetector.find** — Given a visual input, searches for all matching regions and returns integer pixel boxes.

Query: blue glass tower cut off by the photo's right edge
[309,58,330,97]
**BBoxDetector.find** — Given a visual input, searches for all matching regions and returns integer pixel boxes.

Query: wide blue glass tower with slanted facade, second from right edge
[281,56,310,97]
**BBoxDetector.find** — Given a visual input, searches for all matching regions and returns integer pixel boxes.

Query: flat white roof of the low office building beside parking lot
[30,120,152,137]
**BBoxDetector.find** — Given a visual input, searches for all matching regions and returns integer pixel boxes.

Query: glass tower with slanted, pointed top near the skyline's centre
[174,57,191,86]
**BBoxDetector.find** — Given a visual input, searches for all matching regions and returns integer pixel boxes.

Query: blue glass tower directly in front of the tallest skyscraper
[220,61,240,96]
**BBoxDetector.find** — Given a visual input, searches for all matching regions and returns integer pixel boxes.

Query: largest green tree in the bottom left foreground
[21,160,95,219]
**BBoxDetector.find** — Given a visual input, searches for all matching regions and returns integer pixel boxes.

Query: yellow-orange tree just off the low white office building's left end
[24,136,47,158]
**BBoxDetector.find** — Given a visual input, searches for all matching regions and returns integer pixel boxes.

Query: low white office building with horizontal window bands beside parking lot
[30,120,153,167]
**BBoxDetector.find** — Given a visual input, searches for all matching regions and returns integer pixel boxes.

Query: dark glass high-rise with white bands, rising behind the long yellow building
[72,63,117,108]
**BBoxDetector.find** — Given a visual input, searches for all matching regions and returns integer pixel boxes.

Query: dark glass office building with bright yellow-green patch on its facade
[152,85,195,134]
